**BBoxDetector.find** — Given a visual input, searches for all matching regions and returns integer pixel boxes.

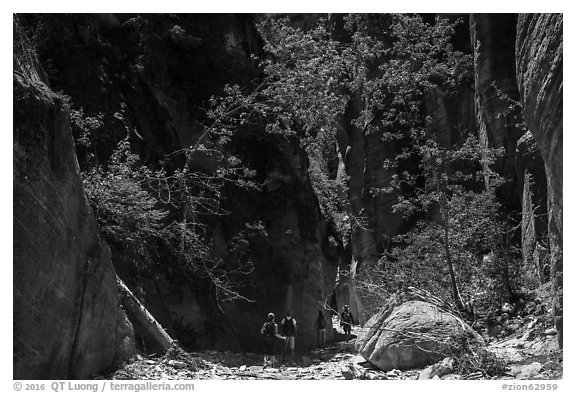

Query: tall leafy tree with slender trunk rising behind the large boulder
[324,14,510,309]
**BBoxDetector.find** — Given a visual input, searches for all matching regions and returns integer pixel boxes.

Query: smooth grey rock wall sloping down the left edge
[13,21,134,379]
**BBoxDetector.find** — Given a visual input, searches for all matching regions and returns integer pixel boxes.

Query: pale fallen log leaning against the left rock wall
[116,276,174,352]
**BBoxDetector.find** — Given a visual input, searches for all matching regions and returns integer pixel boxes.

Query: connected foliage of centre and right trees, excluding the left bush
[201,14,520,312]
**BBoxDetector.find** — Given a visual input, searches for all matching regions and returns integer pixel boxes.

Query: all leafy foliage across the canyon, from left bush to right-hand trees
[77,14,524,316]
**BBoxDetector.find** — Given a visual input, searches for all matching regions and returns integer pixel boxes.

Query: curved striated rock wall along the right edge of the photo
[516,14,563,342]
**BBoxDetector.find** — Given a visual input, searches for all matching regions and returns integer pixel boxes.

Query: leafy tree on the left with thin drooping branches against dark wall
[82,132,252,301]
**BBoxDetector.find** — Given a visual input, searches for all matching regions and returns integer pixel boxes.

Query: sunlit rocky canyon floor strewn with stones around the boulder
[107,297,562,380]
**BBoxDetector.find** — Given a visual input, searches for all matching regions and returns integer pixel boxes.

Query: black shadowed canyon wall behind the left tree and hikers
[18,14,340,352]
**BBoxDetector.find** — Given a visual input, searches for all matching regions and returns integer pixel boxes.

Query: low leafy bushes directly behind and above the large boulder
[361,187,514,306]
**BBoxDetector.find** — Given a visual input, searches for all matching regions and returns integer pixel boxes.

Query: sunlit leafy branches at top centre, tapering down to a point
[202,16,351,224]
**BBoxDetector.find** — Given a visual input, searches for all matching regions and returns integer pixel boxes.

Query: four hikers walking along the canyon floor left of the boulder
[260,305,354,367]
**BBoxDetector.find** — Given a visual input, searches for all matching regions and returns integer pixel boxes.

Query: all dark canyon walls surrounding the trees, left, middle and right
[14,14,563,362]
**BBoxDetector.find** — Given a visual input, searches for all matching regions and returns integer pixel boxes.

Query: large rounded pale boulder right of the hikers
[356,300,483,371]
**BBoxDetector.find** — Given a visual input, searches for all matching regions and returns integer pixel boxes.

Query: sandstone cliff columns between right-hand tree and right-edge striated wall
[470,14,549,282]
